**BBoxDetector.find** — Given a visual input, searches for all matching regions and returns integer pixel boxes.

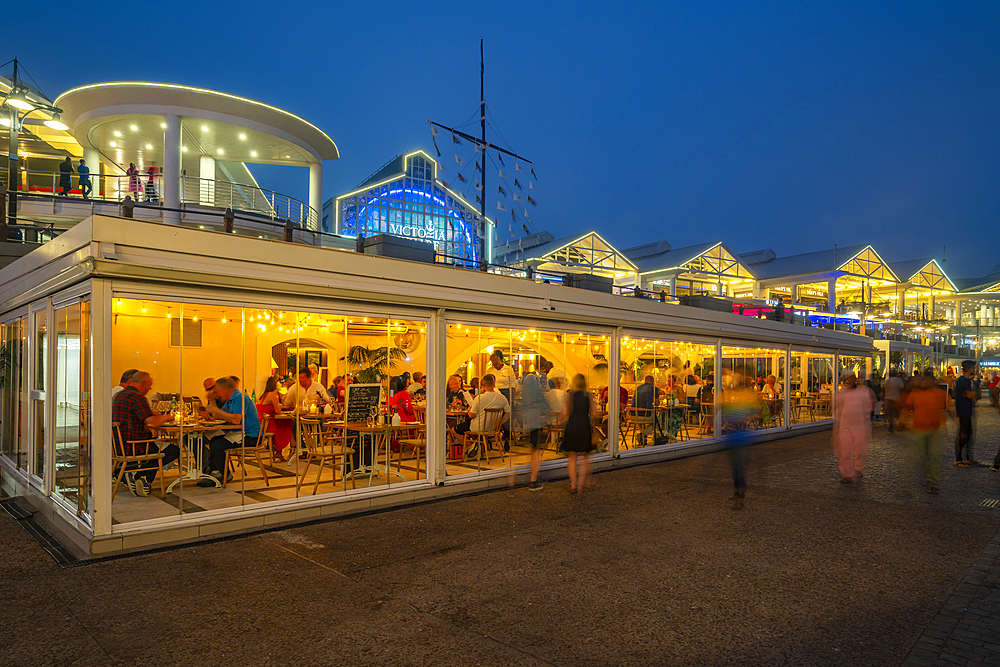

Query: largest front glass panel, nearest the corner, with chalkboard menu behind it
[112,299,427,523]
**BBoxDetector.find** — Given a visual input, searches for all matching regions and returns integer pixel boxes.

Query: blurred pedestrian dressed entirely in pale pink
[833,373,875,484]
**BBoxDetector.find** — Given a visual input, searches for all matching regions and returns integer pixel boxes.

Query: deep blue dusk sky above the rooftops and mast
[0,2,1000,277]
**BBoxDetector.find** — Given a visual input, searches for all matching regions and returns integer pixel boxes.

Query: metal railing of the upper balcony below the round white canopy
[0,169,319,231]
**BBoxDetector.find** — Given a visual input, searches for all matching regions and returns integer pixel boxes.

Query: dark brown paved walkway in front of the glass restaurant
[0,409,1000,667]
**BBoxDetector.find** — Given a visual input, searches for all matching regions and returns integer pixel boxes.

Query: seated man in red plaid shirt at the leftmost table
[111,371,180,496]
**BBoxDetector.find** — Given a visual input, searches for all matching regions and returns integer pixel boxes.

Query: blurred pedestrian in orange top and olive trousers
[901,371,948,495]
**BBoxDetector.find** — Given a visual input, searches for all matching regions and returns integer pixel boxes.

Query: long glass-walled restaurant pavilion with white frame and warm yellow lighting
[0,216,872,554]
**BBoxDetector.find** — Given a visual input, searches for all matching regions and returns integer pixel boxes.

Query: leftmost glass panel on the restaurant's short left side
[0,318,28,472]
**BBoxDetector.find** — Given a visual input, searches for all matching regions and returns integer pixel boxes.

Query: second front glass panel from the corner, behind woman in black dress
[442,322,610,476]
